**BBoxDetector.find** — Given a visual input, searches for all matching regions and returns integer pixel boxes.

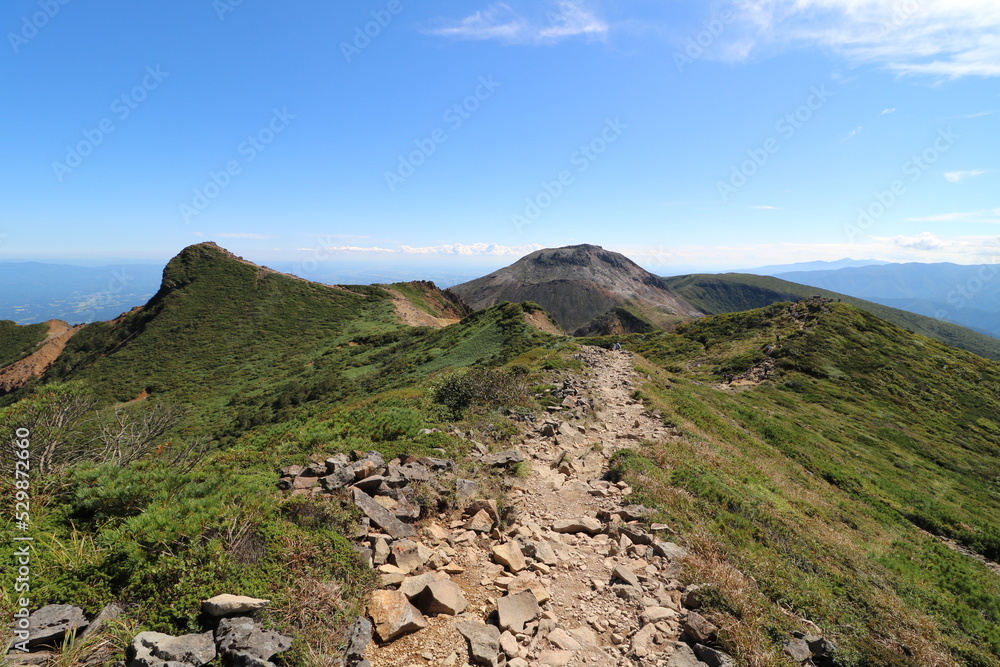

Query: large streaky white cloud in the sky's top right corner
[727,0,1000,78]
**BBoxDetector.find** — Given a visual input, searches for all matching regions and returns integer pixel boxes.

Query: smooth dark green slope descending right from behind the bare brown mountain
[663,273,1000,360]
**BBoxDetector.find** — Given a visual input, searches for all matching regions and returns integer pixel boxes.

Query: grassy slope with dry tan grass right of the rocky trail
[588,304,1000,667]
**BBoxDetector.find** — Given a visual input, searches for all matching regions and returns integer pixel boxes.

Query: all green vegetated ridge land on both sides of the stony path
[0,244,1000,667]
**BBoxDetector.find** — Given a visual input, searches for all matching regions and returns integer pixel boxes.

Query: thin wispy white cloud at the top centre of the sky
[425,0,610,44]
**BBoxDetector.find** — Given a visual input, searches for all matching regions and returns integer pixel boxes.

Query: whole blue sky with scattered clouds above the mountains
[0,0,1000,273]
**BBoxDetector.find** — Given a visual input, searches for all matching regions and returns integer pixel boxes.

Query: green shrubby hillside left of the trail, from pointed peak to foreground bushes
[0,254,558,665]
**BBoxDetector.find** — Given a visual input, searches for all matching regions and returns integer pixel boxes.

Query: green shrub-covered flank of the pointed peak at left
[36,245,398,436]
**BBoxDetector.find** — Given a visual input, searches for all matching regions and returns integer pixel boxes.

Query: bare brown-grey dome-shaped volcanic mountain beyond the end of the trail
[451,244,704,334]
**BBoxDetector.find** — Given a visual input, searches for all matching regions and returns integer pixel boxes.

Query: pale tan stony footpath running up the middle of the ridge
[345,347,833,667]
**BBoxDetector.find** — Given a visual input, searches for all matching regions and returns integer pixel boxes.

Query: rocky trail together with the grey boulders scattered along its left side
[6,347,836,667]
